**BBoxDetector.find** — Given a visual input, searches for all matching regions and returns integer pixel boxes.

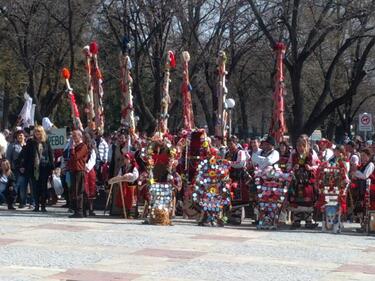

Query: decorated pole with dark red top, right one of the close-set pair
[89,42,104,132]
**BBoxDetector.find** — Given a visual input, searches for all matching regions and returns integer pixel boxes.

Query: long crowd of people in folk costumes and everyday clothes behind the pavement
[0,126,375,228]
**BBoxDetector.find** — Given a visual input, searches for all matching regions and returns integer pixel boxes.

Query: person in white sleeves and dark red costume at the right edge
[351,148,375,231]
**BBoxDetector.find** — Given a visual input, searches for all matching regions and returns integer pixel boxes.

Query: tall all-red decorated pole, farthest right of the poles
[270,42,287,143]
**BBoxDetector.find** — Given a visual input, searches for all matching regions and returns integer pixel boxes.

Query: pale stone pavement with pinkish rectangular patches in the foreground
[0,203,375,281]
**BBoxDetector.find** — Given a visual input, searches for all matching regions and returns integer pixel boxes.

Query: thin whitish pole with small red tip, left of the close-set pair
[83,46,96,129]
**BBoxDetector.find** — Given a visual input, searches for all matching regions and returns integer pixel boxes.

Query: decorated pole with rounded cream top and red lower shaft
[181,51,194,131]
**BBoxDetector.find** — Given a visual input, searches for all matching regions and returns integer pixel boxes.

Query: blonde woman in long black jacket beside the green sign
[22,126,54,212]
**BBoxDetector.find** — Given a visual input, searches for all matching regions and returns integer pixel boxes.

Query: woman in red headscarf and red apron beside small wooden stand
[109,152,139,219]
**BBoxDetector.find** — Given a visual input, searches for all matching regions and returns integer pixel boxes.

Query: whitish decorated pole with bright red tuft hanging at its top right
[160,51,176,133]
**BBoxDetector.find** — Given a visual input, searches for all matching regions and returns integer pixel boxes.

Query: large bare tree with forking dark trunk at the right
[248,0,375,137]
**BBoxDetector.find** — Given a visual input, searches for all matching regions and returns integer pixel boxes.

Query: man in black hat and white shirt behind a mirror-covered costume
[252,136,280,172]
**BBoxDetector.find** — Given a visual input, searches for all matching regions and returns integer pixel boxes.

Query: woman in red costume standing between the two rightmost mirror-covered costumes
[288,135,318,229]
